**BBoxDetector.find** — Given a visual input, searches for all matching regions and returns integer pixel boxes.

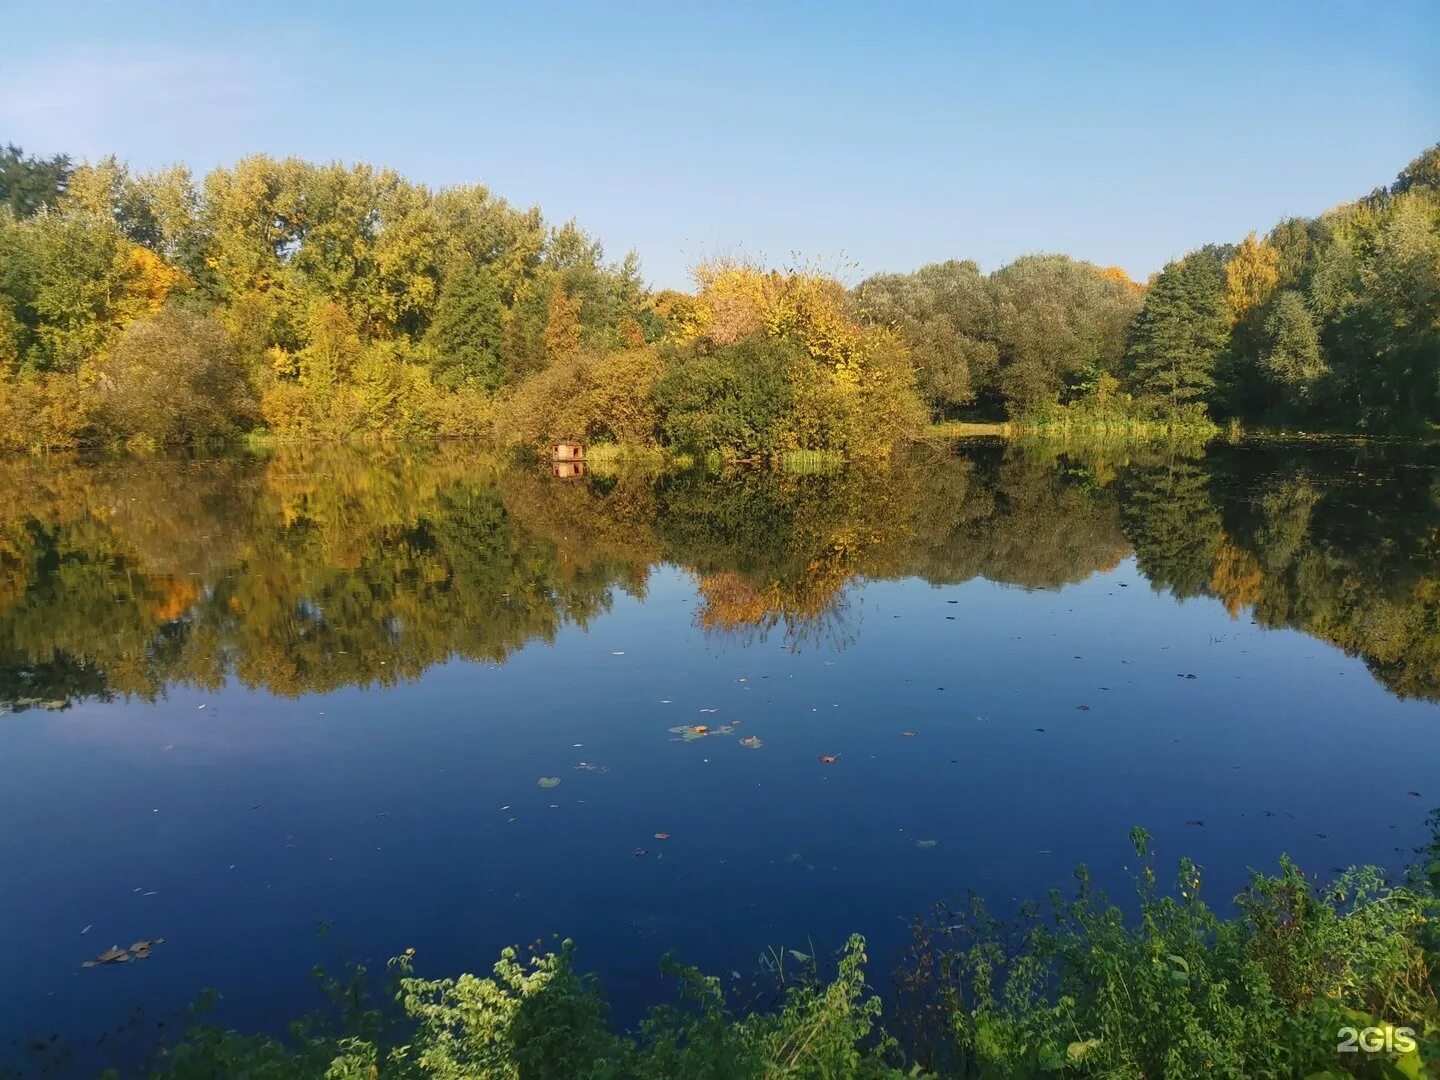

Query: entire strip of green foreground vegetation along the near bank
[90,814,1440,1080]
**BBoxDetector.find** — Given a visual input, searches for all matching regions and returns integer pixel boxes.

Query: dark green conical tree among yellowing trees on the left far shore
[426,262,505,390]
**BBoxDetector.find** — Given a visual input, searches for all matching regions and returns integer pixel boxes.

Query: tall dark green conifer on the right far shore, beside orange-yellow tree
[1125,248,1230,413]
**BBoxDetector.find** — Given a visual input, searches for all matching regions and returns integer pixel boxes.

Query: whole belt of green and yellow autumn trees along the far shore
[0,145,1440,461]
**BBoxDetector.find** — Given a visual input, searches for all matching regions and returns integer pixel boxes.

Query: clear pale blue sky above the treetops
[0,0,1440,287]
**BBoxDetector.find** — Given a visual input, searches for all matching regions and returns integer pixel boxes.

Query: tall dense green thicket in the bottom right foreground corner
[901,829,1440,1080]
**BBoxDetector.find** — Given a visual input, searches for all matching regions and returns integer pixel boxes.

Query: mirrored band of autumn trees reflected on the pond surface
[0,444,1440,710]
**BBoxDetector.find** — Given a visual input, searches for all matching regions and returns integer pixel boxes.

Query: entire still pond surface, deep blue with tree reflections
[0,444,1440,1066]
